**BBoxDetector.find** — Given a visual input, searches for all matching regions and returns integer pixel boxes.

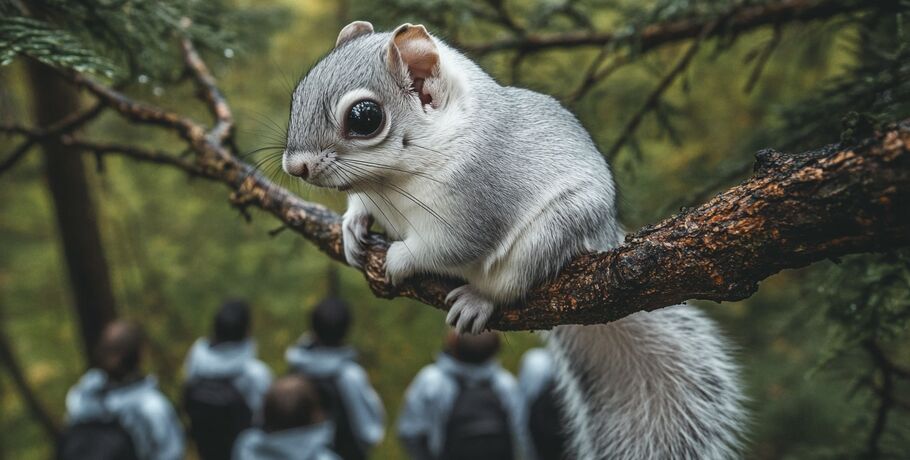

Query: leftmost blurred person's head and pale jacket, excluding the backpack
[66,321,184,460]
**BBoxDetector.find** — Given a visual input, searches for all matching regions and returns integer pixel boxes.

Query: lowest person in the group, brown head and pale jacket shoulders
[232,375,339,460]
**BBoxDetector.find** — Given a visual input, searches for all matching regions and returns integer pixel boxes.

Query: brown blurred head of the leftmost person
[95,320,145,382]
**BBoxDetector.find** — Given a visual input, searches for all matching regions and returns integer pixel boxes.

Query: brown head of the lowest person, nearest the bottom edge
[262,374,325,433]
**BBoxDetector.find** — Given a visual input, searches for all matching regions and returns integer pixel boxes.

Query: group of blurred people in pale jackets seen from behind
[57,298,566,460]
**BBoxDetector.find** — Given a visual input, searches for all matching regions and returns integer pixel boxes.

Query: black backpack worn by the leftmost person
[57,417,139,460]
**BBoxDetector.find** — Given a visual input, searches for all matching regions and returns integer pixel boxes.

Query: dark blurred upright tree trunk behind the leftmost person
[29,62,116,364]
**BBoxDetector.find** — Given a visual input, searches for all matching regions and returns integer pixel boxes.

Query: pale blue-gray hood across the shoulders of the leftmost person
[66,369,158,420]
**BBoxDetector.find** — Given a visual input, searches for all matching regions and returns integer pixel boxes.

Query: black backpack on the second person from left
[183,377,253,460]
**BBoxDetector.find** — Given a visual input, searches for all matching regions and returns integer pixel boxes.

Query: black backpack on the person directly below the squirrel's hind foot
[441,377,515,460]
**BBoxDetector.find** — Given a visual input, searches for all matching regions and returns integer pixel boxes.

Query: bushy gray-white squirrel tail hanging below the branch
[548,305,746,460]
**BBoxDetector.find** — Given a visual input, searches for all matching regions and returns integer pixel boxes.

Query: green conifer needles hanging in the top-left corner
[0,0,286,81]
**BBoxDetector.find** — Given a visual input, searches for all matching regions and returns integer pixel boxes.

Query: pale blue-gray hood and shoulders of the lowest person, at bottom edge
[245,422,335,460]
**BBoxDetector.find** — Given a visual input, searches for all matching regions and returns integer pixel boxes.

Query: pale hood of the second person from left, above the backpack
[186,338,256,379]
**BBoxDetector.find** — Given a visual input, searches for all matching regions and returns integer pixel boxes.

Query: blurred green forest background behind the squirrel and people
[0,0,910,459]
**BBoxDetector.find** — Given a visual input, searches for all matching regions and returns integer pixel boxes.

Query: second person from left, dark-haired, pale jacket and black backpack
[183,300,272,460]
